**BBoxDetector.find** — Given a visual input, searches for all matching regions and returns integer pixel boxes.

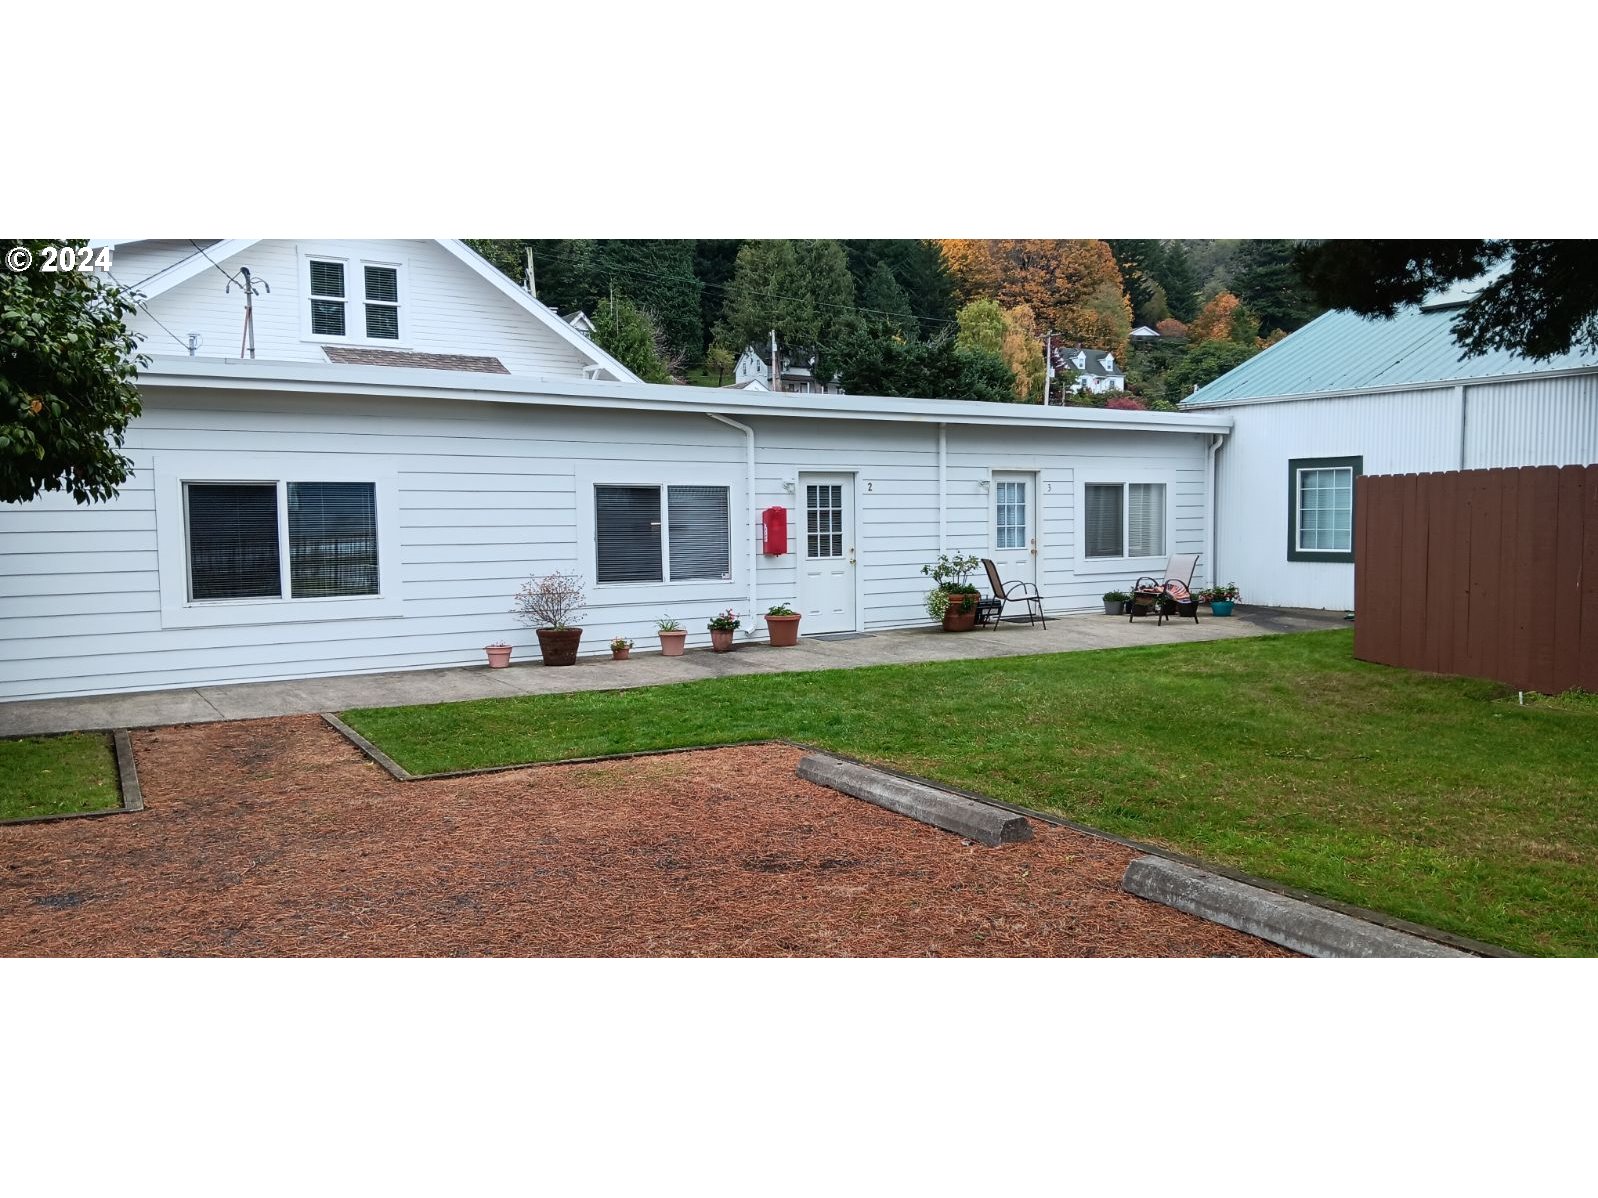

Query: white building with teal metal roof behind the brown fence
[1181,288,1598,609]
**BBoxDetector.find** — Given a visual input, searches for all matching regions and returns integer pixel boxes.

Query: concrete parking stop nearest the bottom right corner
[1120,856,1470,957]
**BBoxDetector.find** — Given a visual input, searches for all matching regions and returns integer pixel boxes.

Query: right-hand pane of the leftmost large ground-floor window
[288,482,379,599]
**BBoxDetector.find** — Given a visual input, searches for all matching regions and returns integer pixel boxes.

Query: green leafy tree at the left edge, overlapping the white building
[0,238,149,503]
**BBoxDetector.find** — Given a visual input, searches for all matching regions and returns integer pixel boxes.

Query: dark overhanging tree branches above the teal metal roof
[1296,240,1598,359]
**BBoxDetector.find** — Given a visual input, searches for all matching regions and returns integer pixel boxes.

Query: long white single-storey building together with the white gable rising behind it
[0,240,1232,698]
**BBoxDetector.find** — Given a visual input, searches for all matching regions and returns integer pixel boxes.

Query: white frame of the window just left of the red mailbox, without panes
[575,463,753,597]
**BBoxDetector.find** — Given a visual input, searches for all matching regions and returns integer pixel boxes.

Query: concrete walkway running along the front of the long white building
[0,607,1347,736]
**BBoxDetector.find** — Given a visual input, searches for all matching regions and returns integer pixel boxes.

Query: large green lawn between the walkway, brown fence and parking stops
[345,629,1598,954]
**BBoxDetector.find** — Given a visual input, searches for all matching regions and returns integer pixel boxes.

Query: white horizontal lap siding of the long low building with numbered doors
[0,393,1203,698]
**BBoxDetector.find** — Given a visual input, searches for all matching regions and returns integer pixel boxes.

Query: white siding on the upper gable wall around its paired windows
[115,241,586,379]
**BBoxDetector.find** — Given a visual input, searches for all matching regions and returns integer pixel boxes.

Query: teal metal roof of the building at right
[1181,303,1598,407]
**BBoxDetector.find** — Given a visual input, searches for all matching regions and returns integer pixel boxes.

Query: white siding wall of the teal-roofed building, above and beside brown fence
[1216,374,1598,610]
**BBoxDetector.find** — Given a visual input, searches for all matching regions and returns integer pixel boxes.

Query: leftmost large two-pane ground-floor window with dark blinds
[184,482,379,602]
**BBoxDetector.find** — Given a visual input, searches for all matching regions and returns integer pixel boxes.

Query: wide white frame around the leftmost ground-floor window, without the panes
[152,454,401,628]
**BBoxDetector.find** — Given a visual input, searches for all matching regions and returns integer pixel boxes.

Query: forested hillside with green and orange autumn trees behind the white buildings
[468,240,1320,407]
